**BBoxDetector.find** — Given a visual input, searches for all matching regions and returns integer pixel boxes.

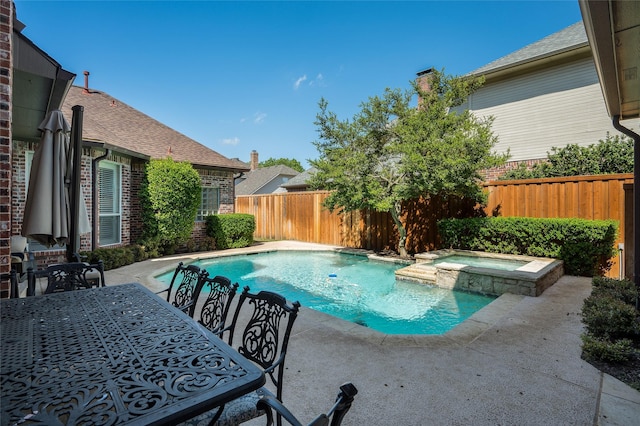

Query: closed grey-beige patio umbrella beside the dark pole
[22,110,91,247]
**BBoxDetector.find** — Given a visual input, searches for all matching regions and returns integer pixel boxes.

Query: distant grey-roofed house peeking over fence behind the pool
[235,150,299,195]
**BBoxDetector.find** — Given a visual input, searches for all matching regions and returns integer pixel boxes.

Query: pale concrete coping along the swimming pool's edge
[149,245,526,347]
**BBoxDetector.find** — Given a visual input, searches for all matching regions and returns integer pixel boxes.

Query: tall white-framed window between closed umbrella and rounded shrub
[99,161,122,246]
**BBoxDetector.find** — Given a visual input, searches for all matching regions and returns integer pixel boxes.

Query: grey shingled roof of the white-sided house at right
[469,21,589,75]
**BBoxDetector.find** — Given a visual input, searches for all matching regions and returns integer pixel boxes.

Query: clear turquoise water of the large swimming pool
[157,251,495,334]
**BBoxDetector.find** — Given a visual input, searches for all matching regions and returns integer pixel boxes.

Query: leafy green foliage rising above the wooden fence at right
[499,133,633,180]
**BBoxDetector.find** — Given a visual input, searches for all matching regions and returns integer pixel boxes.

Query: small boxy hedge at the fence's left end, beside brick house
[206,213,256,250]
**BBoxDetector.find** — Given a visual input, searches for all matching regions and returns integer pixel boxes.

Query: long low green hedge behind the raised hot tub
[438,217,618,276]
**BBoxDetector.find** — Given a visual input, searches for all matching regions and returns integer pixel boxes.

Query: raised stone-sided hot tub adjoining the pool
[396,250,564,296]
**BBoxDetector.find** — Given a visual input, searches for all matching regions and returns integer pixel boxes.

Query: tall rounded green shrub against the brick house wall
[141,158,202,250]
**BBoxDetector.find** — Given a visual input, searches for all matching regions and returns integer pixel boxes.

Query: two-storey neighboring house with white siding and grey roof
[418,22,638,179]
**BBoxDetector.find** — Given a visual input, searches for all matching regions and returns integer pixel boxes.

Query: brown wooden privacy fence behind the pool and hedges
[235,174,633,276]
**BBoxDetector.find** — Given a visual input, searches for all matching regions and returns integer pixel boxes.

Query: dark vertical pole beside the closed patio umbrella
[67,105,84,262]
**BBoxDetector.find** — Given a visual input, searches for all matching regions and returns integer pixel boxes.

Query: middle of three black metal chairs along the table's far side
[189,271,238,335]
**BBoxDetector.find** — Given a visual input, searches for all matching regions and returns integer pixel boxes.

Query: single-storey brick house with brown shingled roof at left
[12,72,248,262]
